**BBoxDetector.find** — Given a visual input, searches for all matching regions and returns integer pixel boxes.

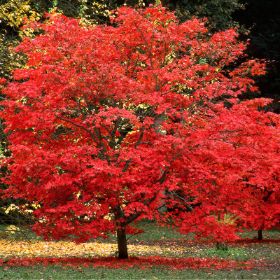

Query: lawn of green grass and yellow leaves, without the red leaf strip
[0,222,280,280]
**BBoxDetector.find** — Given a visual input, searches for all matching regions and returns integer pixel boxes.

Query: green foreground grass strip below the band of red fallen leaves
[0,266,280,280]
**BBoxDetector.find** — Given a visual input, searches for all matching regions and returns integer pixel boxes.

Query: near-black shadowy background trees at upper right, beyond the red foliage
[235,0,280,113]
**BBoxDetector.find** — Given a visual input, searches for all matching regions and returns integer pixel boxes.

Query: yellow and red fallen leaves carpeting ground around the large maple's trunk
[0,239,266,269]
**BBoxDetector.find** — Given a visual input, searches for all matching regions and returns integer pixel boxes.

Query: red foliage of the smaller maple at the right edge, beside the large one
[173,99,280,242]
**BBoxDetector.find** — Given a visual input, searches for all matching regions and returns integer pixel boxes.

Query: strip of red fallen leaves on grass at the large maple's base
[0,257,260,270]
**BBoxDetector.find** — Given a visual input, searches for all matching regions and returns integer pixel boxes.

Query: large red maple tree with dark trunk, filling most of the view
[1,6,279,258]
